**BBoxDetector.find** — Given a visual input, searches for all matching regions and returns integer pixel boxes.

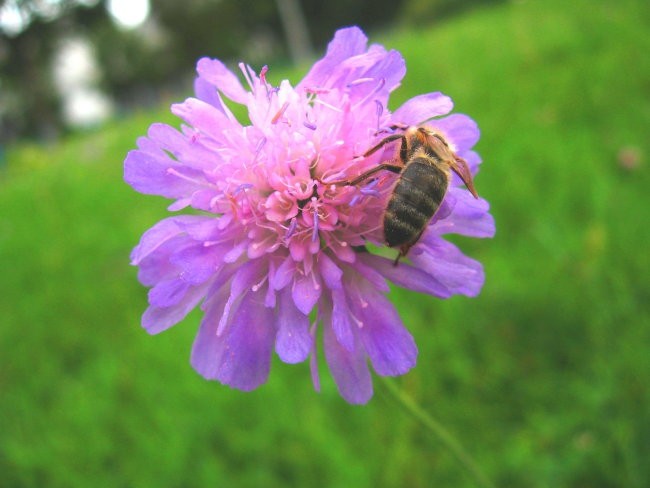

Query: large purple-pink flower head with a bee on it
[124,27,494,403]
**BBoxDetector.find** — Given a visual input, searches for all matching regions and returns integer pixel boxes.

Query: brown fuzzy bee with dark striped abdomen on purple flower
[332,125,478,265]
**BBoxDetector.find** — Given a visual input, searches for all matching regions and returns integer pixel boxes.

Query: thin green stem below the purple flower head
[379,376,494,488]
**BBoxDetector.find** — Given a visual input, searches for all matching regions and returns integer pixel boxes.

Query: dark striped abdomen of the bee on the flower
[384,157,449,255]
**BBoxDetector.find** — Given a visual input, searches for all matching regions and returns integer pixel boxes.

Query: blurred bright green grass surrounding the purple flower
[0,0,650,488]
